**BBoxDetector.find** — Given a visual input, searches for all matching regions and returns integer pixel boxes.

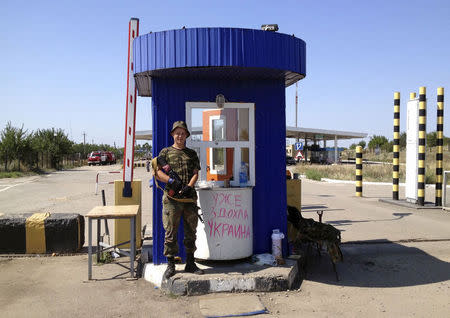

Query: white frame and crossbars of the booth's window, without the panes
[185,102,256,187]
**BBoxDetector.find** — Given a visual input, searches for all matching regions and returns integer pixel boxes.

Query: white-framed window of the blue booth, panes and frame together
[186,102,255,186]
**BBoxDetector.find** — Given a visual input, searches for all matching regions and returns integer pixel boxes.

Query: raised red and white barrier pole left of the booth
[122,18,139,197]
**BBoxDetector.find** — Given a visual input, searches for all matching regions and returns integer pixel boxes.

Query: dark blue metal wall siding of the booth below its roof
[152,76,287,264]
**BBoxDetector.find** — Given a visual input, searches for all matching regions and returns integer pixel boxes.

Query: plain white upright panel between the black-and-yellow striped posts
[405,98,419,203]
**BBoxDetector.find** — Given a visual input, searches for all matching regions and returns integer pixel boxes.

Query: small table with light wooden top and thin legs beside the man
[86,205,139,279]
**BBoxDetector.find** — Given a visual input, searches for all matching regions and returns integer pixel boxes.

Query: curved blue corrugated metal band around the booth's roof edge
[133,28,306,79]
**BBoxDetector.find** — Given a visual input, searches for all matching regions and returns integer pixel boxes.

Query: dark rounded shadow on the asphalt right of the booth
[306,240,450,288]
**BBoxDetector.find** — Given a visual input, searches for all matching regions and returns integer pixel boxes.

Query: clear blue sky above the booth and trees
[0,0,450,147]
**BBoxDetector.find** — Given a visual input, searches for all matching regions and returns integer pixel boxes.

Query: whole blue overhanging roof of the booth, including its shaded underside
[133,28,306,96]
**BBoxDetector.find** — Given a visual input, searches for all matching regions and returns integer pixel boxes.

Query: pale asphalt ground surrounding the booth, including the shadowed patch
[0,166,450,317]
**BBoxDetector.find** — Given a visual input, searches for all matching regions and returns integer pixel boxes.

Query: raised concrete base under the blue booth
[142,255,305,296]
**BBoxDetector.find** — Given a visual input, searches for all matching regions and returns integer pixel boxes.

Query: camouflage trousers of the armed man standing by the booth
[162,195,198,257]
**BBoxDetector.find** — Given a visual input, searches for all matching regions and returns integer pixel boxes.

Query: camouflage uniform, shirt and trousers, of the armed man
[159,147,200,257]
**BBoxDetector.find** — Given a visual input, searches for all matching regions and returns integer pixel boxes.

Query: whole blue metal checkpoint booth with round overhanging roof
[133,28,306,264]
